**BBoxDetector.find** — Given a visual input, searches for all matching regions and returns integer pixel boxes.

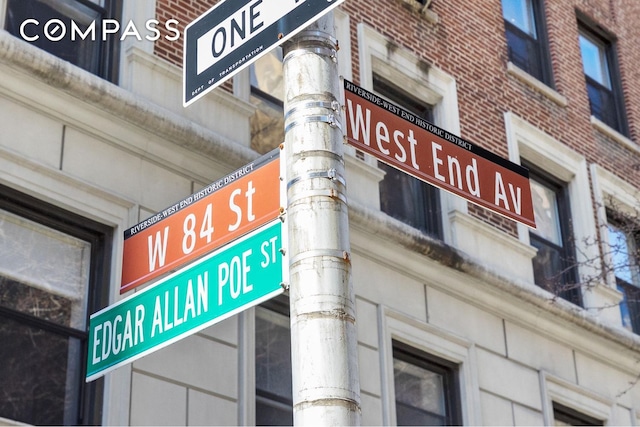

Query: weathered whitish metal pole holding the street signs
[283,13,361,426]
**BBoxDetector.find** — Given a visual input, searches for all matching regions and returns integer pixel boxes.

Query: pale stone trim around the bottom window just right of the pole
[378,306,482,425]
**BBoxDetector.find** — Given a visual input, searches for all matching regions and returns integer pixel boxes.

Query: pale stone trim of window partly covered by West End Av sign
[358,23,467,239]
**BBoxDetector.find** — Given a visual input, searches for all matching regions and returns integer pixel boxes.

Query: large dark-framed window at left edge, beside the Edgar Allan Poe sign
[0,187,111,425]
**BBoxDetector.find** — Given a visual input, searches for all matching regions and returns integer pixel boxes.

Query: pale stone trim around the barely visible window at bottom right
[540,371,615,426]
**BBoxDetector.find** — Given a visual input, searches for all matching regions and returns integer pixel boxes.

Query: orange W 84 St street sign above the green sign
[120,148,281,293]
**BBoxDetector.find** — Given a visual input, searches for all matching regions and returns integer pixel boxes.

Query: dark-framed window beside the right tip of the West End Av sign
[529,167,582,306]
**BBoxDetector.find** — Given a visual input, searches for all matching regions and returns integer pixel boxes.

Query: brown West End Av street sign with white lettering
[344,80,536,228]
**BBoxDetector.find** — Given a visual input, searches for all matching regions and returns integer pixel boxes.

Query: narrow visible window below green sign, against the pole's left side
[256,297,293,426]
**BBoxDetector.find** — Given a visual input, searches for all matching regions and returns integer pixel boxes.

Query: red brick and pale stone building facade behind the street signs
[0,0,640,425]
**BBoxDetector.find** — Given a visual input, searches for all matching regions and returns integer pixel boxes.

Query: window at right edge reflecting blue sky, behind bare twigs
[607,217,640,334]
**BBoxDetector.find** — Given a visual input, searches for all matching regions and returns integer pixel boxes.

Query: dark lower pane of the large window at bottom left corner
[0,315,82,425]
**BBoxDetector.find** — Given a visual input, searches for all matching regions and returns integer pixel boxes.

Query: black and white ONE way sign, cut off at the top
[183,0,345,107]
